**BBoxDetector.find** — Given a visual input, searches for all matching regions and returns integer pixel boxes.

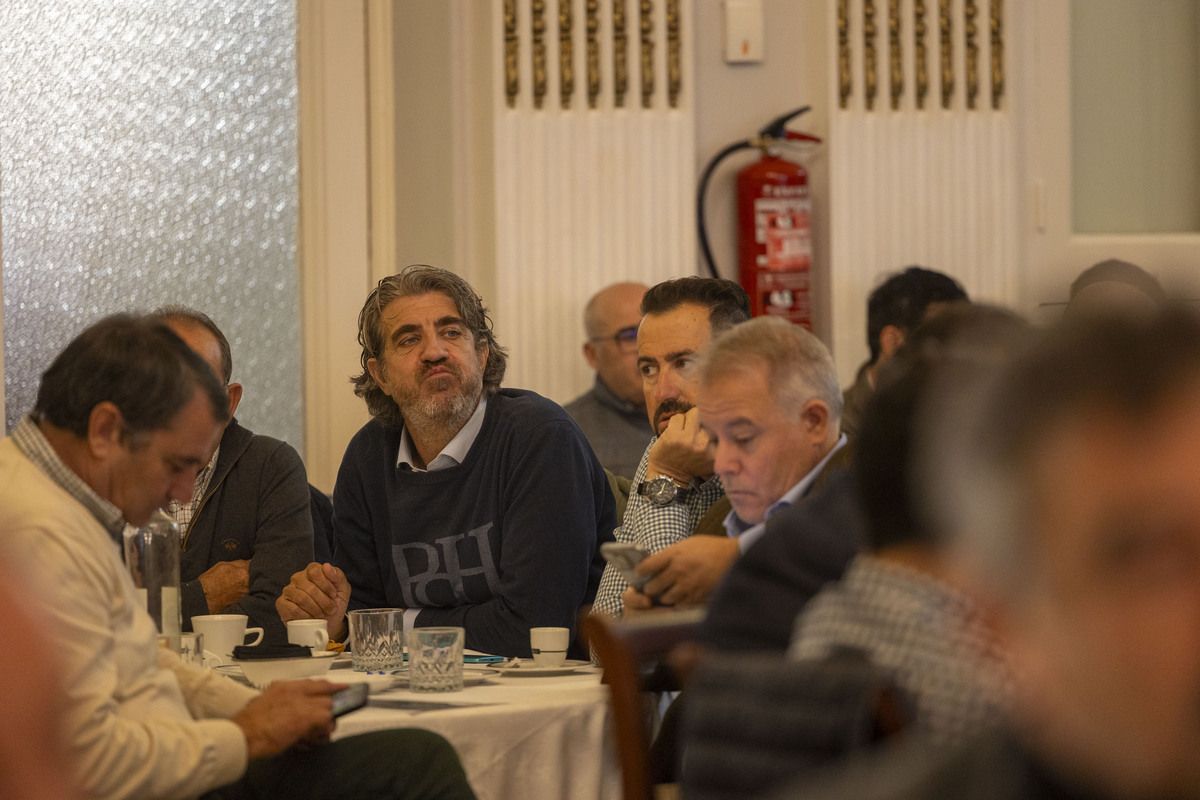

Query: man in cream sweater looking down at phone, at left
[0,315,473,799]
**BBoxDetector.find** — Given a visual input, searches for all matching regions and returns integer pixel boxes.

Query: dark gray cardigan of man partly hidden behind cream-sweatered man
[180,420,313,644]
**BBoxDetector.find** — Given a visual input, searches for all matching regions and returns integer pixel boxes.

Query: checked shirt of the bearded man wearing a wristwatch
[592,437,725,616]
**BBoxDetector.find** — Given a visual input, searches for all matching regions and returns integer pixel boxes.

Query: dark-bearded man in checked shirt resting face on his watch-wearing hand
[593,277,750,616]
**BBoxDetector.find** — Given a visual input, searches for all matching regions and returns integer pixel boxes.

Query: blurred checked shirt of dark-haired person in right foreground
[787,555,1008,745]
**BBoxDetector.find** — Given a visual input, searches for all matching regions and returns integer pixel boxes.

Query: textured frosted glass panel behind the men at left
[0,0,302,447]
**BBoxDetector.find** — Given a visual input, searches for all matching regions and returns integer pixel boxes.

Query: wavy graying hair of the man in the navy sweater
[350,264,509,428]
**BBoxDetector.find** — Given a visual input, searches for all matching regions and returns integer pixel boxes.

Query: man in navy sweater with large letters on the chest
[276,265,617,656]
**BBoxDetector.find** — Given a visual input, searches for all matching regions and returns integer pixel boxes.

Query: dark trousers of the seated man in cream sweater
[204,728,475,800]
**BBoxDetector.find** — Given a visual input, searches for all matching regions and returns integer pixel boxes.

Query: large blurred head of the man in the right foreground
[923,306,1200,798]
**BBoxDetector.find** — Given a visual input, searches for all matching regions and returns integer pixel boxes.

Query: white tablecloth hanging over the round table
[329,667,620,800]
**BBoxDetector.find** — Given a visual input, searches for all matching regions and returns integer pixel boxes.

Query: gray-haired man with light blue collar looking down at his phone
[624,317,850,610]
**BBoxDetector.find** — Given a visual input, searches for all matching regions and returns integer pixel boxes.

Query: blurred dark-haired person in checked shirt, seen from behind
[788,306,1027,746]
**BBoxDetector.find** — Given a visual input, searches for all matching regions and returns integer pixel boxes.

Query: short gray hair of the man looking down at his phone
[700,317,841,420]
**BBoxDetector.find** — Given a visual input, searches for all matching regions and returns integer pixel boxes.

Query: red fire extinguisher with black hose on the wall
[697,106,820,330]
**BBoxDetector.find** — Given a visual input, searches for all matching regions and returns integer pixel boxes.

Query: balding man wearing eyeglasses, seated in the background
[565,283,654,477]
